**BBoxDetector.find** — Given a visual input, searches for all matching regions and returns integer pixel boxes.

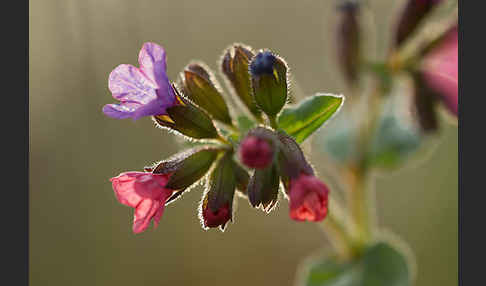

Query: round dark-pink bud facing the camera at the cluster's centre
[240,135,273,169]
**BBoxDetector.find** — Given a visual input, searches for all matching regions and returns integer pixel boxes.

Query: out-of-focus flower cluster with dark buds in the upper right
[336,0,458,133]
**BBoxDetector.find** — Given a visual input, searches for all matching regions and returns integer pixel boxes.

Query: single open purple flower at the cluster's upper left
[103,43,177,120]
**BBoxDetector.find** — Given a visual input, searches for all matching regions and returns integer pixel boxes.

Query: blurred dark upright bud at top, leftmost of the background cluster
[337,0,361,85]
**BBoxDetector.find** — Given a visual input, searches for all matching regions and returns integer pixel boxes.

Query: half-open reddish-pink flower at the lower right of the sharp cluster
[289,173,329,221]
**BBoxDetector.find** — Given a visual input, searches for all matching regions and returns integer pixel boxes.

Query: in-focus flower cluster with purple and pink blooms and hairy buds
[103,43,343,233]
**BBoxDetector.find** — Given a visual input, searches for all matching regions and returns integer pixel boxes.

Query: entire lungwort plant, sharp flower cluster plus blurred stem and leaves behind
[103,0,458,286]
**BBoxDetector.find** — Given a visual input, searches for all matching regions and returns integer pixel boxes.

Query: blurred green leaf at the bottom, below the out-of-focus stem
[304,242,411,286]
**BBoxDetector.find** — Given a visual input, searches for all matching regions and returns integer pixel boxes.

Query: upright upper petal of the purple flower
[138,43,167,87]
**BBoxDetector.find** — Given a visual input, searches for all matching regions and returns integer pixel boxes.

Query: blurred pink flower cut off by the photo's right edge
[423,26,459,116]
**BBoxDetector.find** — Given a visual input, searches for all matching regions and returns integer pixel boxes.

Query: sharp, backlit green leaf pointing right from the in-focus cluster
[278,94,344,143]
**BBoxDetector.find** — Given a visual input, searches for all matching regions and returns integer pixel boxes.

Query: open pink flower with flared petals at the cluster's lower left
[110,172,173,233]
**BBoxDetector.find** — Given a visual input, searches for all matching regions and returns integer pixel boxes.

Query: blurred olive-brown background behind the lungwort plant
[29,0,458,286]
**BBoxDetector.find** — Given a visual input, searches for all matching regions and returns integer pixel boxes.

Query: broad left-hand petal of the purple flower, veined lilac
[108,64,158,104]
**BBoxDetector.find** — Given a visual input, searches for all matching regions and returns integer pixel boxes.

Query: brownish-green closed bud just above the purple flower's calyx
[181,63,232,125]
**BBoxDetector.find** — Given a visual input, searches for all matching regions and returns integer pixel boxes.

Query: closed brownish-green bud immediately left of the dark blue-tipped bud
[221,44,261,118]
